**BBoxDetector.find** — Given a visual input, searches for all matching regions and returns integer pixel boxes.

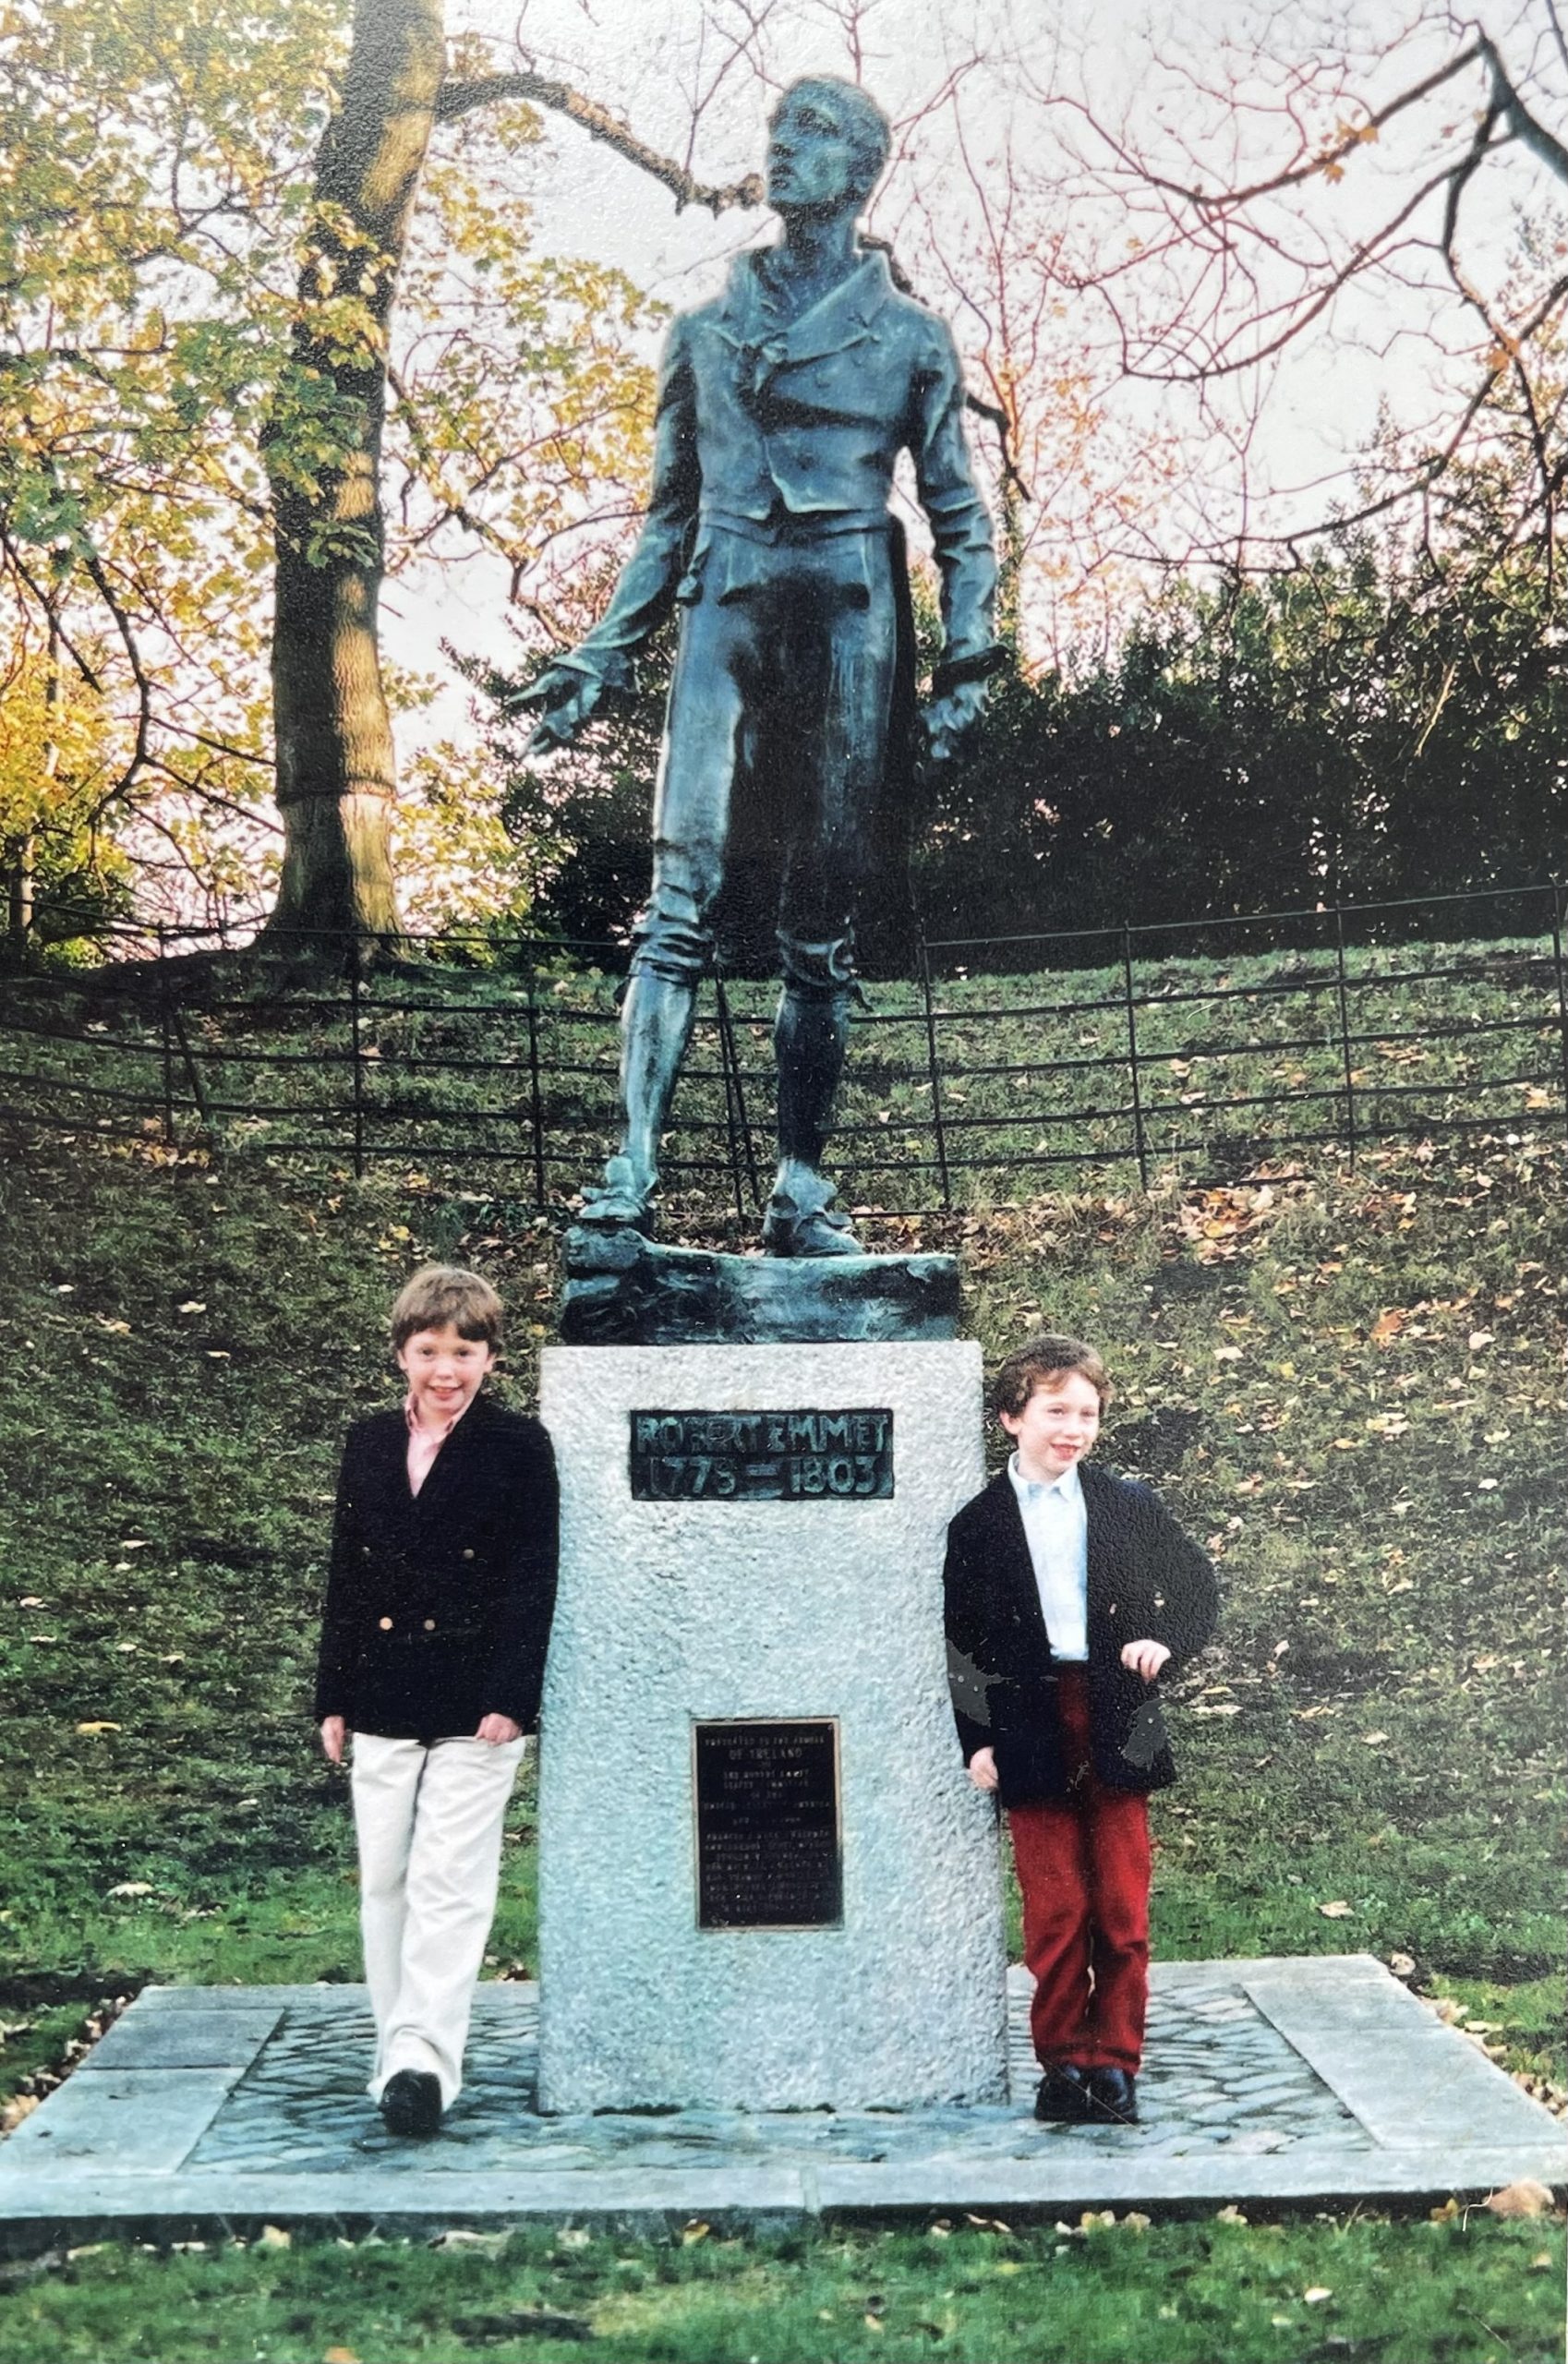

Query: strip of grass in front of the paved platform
[0,2217,1563,2364]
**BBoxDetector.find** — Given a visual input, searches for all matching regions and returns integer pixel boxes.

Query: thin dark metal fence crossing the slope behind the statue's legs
[0,882,1568,1217]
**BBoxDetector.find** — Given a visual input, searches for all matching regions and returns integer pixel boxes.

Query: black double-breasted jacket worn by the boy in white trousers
[315,1394,558,1740]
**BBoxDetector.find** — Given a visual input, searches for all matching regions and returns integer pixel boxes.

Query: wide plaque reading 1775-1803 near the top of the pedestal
[629,1406,894,1502]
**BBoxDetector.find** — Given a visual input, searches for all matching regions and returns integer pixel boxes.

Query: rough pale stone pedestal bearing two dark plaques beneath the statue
[539,1341,1007,2111]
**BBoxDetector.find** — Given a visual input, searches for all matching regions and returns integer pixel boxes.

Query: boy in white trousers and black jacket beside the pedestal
[315,1265,558,2140]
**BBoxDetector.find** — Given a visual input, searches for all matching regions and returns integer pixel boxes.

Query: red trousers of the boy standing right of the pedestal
[1007,1667,1152,2073]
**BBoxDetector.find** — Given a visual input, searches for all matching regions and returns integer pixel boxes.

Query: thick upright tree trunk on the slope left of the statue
[265,0,444,948]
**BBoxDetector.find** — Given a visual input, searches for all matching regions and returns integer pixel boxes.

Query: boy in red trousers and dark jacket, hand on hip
[944,1335,1215,2125]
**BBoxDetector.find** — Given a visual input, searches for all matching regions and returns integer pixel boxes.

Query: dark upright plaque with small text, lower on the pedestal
[691,1717,844,1929]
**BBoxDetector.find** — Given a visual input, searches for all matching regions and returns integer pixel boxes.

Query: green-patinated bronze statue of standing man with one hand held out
[525,78,1000,1255]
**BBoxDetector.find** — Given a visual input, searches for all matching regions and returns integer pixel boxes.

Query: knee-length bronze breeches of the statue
[633,527,899,995]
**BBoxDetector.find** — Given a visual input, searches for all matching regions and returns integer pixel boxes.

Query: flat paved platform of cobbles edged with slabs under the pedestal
[0,1955,1568,2249]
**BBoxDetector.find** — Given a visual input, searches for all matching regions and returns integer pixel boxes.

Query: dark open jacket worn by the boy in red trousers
[944,1461,1218,1806]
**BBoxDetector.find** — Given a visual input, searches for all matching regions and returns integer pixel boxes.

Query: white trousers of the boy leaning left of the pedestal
[353,1732,527,2109]
